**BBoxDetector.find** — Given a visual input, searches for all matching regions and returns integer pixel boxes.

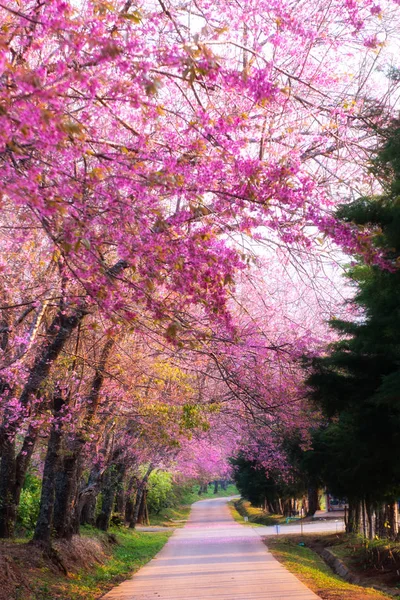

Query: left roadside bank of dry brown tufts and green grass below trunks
[0,527,171,600]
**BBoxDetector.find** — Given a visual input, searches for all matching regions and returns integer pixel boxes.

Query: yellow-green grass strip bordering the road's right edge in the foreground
[266,537,389,600]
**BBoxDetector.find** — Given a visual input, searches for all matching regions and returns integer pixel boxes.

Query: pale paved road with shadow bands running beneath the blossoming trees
[103,498,318,600]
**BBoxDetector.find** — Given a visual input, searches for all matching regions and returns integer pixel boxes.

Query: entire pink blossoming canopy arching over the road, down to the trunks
[0,0,399,544]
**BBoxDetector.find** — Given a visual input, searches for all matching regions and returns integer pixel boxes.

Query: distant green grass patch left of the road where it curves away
[150,485,238,527]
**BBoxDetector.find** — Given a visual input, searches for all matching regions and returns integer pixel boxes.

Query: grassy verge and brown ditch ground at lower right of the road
[264,533,400,600]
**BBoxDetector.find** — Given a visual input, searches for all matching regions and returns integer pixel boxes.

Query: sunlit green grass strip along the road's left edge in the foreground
[32,529,171,600]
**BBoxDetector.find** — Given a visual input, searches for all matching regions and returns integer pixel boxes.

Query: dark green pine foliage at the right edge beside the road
[306,129,400,502]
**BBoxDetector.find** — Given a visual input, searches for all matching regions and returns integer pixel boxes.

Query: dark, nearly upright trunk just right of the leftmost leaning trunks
[33,398,64,546]
